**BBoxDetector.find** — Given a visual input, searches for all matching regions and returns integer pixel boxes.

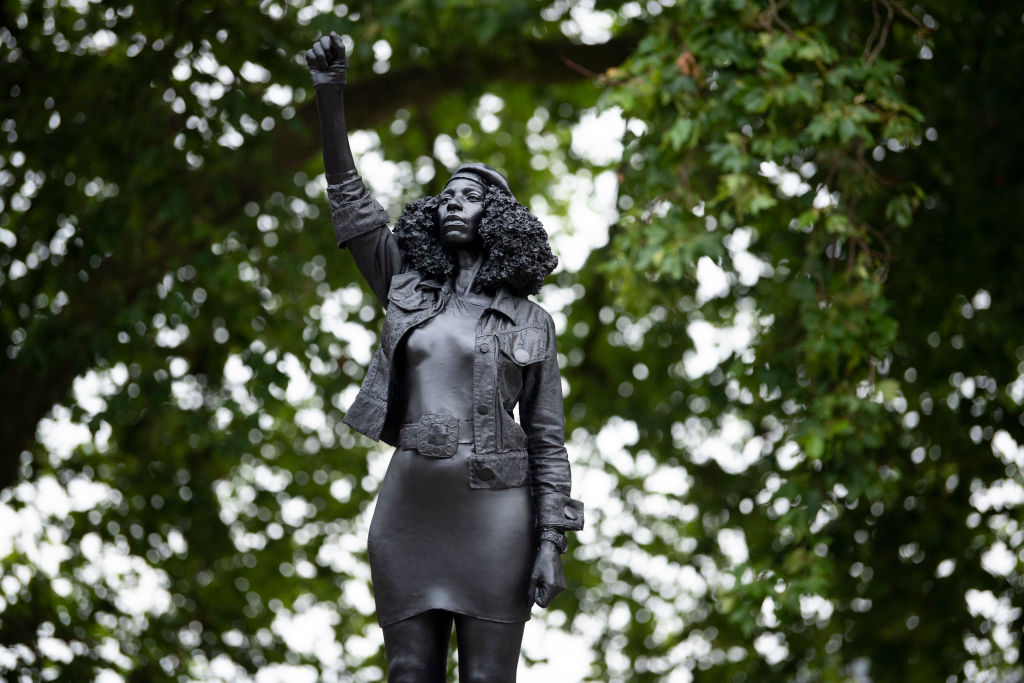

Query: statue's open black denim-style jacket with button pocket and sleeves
[328,175,583,530]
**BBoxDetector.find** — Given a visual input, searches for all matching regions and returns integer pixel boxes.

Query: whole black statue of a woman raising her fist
[306,34,583,683]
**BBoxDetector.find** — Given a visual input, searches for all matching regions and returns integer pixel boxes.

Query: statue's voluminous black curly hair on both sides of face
[394,186,558,297]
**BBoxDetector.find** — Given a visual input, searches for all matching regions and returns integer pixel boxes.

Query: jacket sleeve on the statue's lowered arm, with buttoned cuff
[519,315,583,531]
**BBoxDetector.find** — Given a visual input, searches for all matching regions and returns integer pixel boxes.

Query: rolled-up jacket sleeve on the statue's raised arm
[327,171,403,306]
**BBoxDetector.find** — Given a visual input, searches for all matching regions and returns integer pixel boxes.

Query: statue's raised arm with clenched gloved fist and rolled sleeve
[306,32,402,305]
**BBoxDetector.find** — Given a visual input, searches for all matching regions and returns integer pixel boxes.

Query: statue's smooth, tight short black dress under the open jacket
[369,294,536,627]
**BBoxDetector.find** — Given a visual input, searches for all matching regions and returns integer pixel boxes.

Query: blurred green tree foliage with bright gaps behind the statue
[0,0,1024,681]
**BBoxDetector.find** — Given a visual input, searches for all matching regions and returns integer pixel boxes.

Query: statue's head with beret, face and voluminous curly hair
[394,163,558,295]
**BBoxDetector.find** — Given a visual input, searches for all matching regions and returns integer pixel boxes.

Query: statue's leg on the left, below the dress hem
[384,609,452,683]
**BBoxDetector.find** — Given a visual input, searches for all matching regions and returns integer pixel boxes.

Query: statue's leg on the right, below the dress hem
[455,614,525,683]
